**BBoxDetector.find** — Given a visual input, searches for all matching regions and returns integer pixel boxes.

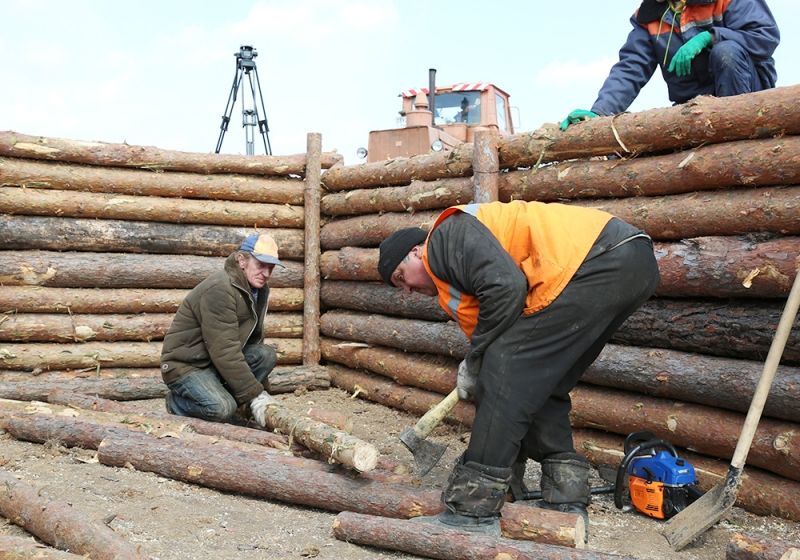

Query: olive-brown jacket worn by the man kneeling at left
[161,254,269,404]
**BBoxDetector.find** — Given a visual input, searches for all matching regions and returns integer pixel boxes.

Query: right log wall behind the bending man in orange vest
[320,86,800,518]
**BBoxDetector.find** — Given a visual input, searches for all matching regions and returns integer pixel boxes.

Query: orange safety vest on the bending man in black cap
[422,200,612,338]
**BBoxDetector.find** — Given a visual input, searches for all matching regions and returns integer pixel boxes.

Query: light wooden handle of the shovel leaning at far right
[731,271,800,469]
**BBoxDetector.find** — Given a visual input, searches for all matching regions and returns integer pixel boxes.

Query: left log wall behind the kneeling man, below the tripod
[0,132,341,382]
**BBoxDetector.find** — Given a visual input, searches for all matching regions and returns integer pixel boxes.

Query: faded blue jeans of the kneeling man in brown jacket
[166,344,278,422]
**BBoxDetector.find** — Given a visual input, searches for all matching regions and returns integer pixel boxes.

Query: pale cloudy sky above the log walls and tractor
[0,0,800,164]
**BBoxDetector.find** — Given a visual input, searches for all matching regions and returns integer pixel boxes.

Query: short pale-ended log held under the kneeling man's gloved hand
[266,404,380,472]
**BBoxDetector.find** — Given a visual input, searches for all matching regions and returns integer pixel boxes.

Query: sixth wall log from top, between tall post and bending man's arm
[320,310,469,359]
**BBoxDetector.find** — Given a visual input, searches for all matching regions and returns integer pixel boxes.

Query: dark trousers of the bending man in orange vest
[464,234,659,467]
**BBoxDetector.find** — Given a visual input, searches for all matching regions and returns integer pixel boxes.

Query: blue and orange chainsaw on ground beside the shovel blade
[614,432,702,519]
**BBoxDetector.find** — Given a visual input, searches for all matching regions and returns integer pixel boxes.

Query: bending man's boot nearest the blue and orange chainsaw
[534,452,591,541]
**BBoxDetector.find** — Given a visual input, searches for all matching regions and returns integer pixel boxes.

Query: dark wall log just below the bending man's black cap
[322,281,450,321]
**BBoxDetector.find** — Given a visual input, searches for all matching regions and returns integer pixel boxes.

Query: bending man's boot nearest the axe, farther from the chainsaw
[414,457,511,537]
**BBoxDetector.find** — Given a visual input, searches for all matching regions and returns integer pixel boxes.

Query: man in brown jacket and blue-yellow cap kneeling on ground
[161,234,283,426]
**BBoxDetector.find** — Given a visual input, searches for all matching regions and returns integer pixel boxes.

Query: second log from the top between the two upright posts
[322,178,472,216]
